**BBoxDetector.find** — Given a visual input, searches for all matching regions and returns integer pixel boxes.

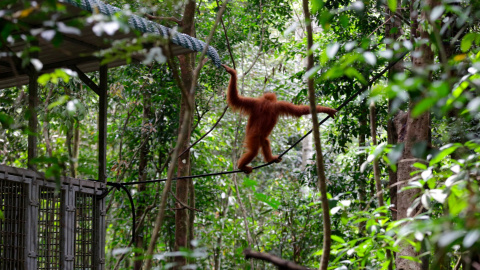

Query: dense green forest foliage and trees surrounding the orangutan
[0,0,480,269]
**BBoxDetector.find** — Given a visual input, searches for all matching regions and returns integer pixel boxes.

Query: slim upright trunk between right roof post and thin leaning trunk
[133,90,152,270]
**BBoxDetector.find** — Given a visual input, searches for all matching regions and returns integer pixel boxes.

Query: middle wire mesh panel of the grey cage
[37,186,62,270]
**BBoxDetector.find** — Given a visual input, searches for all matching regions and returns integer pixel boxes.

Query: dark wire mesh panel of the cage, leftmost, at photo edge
[0,179,26,269]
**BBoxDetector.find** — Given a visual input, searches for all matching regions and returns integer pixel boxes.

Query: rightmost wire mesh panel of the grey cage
[74,192,96,269]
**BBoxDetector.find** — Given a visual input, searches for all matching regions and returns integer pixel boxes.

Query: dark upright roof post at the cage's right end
[98,65,108,183]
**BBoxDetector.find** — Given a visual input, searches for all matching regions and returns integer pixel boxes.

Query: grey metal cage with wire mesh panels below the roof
[0,165,105,270]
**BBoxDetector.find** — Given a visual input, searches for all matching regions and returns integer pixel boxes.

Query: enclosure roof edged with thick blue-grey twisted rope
[0,0,220,89]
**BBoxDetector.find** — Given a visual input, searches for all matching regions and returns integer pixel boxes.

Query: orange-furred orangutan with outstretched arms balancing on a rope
[223,65,337,174]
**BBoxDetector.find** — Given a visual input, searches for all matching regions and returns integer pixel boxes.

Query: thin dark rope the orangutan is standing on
[107,51,408,187]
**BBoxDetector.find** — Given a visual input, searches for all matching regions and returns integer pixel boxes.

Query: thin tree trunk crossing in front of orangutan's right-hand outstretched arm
[303,0,332,270]
